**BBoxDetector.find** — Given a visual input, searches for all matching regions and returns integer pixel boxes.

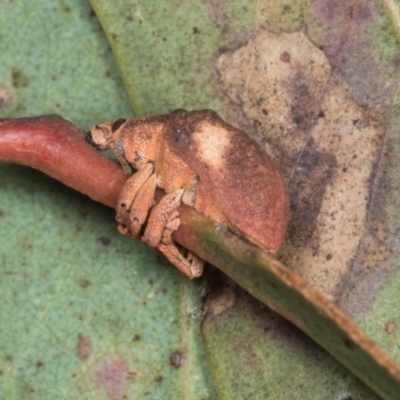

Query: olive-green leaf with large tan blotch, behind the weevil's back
[88,0,400,398]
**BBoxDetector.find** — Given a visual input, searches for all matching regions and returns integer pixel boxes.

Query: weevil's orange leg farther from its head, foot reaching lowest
[142,189,204,278]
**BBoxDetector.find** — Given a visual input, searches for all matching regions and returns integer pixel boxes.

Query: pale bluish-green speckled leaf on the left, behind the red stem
[0,0,214,400]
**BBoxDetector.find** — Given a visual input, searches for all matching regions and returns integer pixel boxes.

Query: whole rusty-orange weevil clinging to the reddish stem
[86,110,289,278]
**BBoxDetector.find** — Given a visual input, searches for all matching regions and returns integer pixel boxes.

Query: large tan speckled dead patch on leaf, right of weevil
[216,29,385,298]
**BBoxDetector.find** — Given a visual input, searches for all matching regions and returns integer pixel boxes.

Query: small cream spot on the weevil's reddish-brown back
[192,121,231,170]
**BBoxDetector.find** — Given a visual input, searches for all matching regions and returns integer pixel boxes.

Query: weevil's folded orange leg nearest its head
[116,162,156,238]
